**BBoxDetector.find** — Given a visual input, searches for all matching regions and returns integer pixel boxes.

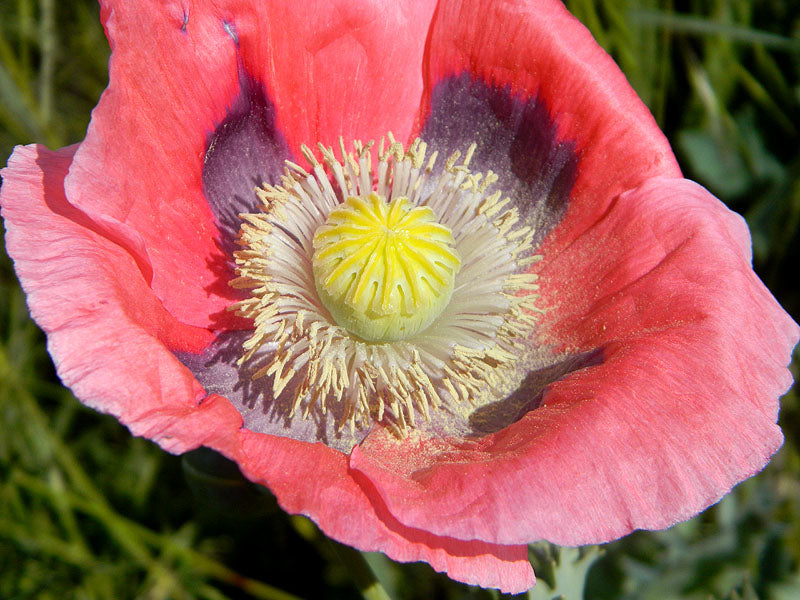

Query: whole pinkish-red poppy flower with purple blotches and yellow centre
[1,0,798,592]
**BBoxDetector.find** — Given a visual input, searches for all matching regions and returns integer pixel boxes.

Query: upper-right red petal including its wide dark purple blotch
[419,0,680,230]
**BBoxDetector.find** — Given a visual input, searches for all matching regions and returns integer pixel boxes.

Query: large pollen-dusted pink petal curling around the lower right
[351,178,798,545]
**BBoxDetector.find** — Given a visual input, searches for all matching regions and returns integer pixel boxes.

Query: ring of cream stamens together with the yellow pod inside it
[231,135,537,435]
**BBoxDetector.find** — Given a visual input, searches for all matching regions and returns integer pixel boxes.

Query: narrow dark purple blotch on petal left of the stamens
[203,71,291,256]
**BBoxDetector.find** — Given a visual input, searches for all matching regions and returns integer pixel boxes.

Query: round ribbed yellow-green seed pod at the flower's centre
[312,192,461,342]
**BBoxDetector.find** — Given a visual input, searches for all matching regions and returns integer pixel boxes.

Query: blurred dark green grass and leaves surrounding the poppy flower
[0,0,800,600]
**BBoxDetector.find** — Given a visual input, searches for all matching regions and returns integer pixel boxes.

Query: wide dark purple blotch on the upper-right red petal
[420,73,579,243]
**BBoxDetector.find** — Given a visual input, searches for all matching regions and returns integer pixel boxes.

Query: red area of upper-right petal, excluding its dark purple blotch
[419,0,680,222]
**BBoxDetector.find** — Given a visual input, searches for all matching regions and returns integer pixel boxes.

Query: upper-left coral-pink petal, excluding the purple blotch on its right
[70,1,247,327]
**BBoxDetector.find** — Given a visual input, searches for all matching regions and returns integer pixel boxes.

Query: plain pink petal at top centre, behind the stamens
[220,0,436,156]
